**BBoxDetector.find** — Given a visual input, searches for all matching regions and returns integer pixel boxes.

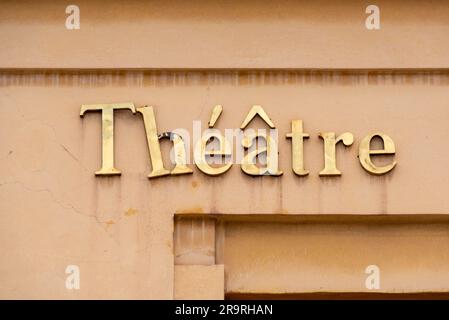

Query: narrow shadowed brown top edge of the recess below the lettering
[174,212,449,224]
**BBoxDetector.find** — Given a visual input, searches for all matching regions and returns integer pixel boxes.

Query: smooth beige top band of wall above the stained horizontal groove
[0,0,449,69]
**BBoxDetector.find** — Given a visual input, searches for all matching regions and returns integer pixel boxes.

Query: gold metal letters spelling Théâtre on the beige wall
[80,103,396,178]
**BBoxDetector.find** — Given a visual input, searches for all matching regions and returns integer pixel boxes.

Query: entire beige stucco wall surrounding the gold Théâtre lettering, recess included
[0,1,449,299]
